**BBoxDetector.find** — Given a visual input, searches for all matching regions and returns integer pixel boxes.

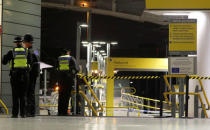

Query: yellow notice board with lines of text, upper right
[169,19,197,55]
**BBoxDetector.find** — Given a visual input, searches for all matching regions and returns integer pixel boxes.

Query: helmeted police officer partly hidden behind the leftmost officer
[23,34,39,117]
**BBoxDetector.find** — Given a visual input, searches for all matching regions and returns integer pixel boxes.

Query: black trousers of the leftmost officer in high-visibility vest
[10,69,29,116]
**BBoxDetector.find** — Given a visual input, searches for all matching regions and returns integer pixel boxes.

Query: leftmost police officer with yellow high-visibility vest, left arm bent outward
[2,37,31,118]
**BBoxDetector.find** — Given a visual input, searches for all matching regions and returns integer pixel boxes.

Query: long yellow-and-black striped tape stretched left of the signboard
[79,75,161,79]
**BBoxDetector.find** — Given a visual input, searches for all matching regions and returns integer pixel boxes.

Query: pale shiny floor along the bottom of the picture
[0,116,210,130]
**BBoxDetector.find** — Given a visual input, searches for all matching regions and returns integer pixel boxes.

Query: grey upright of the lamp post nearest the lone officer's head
[76,22,81,64]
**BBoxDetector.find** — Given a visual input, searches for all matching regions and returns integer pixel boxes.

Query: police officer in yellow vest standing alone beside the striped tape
[58,50,79,116]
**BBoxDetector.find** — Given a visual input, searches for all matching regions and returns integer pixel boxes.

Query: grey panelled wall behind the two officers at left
[0,0,41,111]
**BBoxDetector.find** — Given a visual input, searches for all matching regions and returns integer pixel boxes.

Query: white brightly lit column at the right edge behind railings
[189,11,210,116]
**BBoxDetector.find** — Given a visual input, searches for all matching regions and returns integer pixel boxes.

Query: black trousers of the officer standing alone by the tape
[58,72,74,116]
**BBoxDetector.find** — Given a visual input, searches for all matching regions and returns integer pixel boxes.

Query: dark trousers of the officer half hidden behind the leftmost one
[27,74,37,116]
